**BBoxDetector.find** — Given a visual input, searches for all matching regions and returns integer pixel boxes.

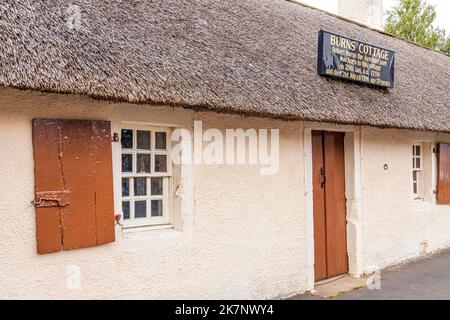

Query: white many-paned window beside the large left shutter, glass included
[120,126,172,228]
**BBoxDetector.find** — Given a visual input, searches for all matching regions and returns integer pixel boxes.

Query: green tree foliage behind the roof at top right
[384,0,450,54]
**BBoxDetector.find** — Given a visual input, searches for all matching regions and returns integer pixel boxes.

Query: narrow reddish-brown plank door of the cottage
[312,131,348,281]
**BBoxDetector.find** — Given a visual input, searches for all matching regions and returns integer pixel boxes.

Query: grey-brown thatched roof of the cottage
[0,0,450,132]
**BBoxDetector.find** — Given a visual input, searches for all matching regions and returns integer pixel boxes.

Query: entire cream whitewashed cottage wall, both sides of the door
[0,88,450,299]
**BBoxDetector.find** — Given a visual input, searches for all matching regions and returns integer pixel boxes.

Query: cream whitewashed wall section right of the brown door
[362,128,450,271]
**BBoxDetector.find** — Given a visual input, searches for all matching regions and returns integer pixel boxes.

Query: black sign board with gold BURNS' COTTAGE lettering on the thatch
[317,30,395,88]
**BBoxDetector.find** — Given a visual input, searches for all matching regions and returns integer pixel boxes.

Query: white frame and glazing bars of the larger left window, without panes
[117,122,173,230]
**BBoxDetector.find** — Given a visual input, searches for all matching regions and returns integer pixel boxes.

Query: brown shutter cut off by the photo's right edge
[437,143,450,204]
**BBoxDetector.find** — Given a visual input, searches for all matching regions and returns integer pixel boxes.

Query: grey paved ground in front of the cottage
[294,250,450,300]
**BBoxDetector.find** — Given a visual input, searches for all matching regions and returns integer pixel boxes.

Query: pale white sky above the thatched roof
[300,0,450,35]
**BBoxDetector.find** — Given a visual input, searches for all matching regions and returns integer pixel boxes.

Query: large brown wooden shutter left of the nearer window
[33,119,114,253]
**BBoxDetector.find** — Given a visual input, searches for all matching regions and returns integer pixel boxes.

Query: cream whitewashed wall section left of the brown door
[0,89,308,299]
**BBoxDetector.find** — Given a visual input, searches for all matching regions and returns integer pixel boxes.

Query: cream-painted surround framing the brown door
[303,122,364,289]
